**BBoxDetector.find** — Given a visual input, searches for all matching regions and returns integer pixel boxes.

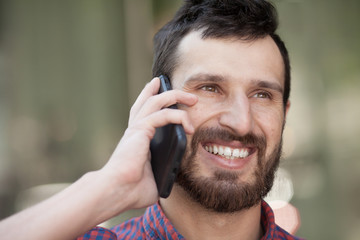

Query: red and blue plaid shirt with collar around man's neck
[77,201,300,240]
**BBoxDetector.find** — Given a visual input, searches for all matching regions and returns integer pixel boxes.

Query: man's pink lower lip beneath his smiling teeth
[200,146,254,170]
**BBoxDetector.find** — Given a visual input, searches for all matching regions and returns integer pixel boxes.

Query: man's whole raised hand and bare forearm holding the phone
[0,78,197,240]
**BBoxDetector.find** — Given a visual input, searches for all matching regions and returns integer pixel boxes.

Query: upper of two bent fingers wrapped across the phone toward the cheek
[134,90,198,119]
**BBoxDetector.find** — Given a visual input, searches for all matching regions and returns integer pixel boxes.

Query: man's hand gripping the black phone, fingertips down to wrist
[97,78,197,211]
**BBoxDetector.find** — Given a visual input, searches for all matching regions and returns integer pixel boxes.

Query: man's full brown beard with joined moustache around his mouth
[176,128,282,213]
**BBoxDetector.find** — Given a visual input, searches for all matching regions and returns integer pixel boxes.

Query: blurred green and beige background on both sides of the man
[0,0,360,240]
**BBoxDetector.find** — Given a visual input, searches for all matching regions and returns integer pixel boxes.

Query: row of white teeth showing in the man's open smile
[204,144,252,160]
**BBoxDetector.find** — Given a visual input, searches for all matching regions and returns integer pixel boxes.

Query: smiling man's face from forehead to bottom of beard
[172,32,288,212]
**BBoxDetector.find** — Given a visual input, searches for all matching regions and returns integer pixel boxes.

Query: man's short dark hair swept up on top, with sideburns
[153,0,290,105]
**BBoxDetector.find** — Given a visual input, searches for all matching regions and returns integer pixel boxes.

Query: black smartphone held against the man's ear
[150,75,186,198]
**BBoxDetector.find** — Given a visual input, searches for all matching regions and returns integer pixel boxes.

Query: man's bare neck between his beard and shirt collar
[160,185,262,240]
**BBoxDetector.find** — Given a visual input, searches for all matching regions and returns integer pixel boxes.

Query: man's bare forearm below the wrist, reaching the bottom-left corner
[0,171,128,240]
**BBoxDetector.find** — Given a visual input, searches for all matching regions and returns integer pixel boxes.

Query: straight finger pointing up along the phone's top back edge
[130,77,160,119]
